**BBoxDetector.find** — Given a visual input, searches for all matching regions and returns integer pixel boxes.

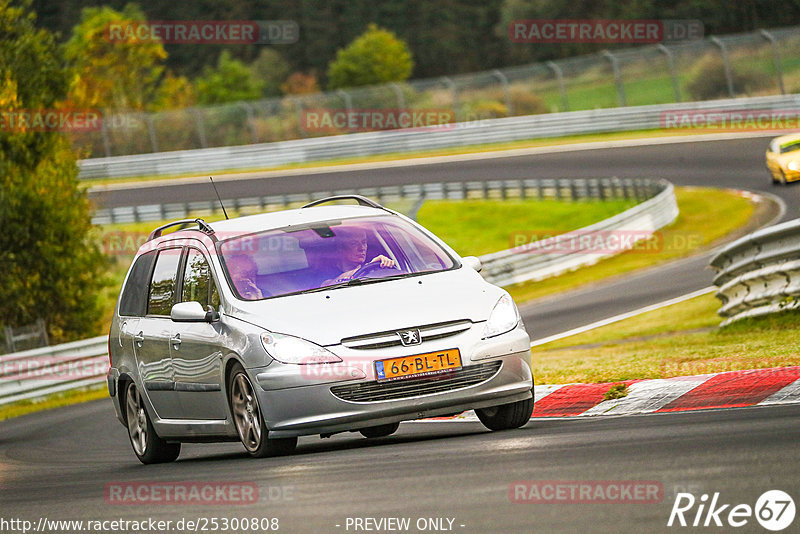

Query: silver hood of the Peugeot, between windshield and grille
[231,267,503,345]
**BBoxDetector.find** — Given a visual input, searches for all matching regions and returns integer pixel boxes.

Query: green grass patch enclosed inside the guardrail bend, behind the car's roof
[417,199,636,256]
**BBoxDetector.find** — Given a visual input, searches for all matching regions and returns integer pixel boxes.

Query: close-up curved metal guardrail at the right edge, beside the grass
[711,219,800,326]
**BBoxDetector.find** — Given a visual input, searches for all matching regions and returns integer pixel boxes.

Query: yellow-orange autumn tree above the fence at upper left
[65,4,167,111]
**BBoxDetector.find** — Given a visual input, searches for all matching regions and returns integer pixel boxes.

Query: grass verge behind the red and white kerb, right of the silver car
[532,294,800,384]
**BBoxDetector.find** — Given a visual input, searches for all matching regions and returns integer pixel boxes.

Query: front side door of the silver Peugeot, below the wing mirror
[170,246,228,420]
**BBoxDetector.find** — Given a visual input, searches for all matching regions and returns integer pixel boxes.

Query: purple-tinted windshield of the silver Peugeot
[218,215,455,300]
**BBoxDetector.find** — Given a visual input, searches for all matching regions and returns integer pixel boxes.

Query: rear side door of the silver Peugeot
[133,247,183,419]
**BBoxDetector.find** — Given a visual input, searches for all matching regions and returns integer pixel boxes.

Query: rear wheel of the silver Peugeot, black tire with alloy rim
[123,382,181,464]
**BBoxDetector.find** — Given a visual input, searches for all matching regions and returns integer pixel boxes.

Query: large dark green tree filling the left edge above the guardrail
[0,0,105,341]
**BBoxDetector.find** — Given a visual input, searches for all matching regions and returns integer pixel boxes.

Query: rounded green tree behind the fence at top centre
[328,24,414,89]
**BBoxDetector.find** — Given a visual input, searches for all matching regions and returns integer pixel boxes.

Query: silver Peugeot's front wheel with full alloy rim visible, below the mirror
[228,363,297,458]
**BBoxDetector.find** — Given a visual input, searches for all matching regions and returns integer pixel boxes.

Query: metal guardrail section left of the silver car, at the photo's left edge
[0,336,109,405]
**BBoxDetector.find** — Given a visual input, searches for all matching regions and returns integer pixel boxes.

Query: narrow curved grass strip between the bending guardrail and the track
[506,187,754,303]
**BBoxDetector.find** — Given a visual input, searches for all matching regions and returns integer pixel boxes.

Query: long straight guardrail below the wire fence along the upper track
[79,95,800,180]
